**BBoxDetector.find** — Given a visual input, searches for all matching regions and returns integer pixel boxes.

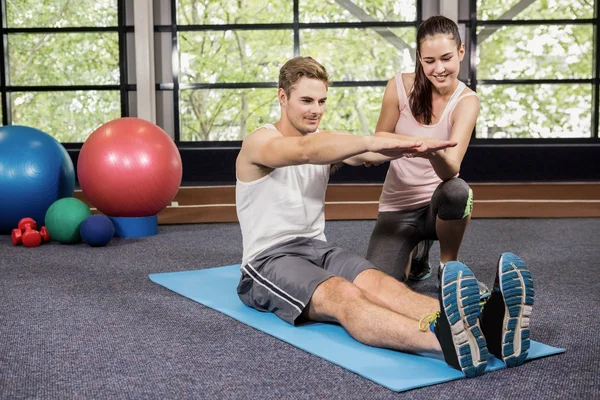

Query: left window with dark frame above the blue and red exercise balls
[0,0,128,143]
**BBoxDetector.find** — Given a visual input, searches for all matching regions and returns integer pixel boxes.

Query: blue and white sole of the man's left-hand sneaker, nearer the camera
[442,261,489,378]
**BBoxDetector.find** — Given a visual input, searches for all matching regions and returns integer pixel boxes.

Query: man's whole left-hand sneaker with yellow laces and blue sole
[419,261,489,378]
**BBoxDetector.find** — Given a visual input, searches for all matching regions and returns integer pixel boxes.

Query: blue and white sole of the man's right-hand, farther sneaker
[498,253,535,367]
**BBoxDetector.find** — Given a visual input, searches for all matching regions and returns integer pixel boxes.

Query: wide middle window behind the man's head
[169,0,419,142]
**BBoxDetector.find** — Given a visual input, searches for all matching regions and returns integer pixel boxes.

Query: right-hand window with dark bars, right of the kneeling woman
[471,0,598,139]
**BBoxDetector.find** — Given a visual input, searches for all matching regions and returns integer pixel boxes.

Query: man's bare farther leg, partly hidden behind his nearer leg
[353,269,440,320]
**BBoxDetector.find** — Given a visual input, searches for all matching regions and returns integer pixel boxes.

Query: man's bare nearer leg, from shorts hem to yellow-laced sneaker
[306,277,442,356]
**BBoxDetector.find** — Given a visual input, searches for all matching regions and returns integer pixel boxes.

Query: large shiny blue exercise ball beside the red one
[0,125,75,234]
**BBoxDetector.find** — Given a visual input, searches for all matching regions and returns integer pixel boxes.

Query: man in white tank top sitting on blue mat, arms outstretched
[236,57,533,376]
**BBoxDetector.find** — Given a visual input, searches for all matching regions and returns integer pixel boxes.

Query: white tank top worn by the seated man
[235,124,330,265]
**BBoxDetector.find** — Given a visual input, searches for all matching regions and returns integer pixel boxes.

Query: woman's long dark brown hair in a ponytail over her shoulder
[409,15,461,125]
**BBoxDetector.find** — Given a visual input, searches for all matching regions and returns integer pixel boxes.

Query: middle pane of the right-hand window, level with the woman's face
[477,25,594,79]
